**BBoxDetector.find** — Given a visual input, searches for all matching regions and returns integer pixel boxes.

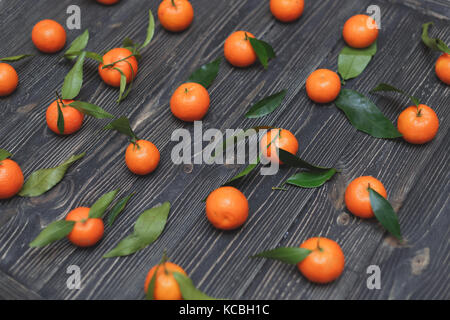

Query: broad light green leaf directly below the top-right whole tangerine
[338,42,377,80]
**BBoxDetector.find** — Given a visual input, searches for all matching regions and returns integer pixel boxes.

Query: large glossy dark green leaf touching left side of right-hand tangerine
[335,89,402,139]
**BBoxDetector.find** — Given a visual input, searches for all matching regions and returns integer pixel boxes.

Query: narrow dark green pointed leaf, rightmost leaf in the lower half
[369,187,402,240]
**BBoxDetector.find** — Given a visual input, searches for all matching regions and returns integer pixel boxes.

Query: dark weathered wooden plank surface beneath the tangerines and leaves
[0,0,450,299]
